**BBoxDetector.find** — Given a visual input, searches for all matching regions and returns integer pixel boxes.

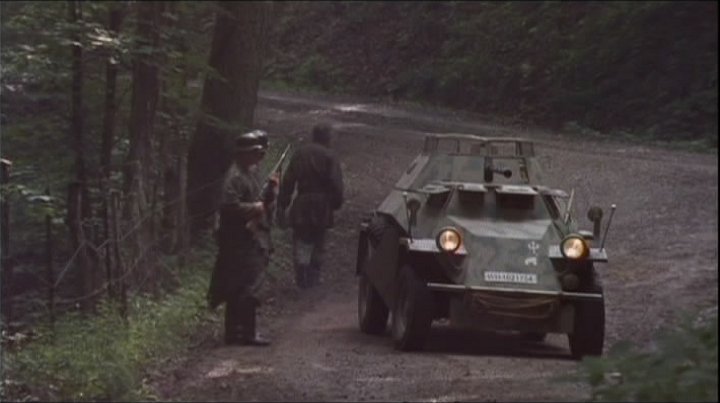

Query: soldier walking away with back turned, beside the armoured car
[277,124,343,288]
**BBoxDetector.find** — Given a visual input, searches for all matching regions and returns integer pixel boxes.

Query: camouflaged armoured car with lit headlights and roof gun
[355,134,615,358]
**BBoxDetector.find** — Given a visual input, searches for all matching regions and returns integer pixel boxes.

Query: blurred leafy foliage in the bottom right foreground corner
[581,313,718,402]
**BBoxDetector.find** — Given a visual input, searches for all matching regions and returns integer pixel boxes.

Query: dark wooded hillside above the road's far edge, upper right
[267,1,718,144]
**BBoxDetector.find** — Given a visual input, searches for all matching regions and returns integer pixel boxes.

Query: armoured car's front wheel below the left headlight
[392,266,435,351]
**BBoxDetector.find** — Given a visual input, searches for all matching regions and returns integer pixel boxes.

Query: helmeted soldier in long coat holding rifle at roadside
[208,130,278,346]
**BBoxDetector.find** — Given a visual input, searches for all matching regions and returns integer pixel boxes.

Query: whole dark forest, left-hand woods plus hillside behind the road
[0,1,718,400]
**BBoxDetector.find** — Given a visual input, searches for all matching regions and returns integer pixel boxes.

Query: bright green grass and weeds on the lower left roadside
[3,252,217,401]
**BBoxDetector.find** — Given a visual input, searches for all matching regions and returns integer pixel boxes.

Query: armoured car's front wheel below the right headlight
[568,287,605,360]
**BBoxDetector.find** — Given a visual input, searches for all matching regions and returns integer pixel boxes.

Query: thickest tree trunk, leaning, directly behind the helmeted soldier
[188,2,272,239]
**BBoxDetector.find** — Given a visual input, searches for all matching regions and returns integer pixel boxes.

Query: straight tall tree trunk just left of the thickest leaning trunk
[122,2,164,294]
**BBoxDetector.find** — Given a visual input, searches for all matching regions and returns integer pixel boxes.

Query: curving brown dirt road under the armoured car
[153,93,718,401]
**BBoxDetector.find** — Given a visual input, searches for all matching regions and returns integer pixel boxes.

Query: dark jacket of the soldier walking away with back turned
[278,143,343,228]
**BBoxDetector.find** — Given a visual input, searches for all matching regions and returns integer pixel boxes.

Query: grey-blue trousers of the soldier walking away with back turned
[293,227,325,288]
